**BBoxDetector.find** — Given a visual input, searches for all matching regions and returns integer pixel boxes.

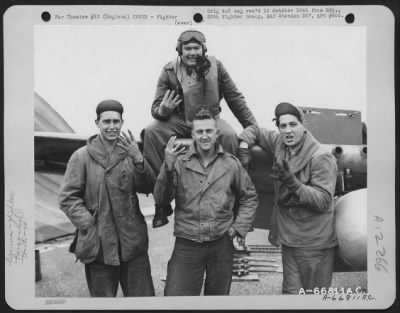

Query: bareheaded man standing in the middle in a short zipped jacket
[154,110,258,296]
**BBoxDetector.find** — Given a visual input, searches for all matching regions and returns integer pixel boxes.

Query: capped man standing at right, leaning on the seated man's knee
[239,102,337,294]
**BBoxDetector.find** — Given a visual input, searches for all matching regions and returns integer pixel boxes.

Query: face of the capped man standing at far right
[279,114,305,147]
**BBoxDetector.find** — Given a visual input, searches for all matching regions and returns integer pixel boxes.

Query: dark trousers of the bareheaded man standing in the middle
[164,234,233,296]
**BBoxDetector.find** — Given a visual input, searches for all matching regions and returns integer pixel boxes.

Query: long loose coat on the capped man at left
[59,135,154,265]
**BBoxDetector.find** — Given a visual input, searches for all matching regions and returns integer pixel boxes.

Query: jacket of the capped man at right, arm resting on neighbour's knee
[239,126,337,248]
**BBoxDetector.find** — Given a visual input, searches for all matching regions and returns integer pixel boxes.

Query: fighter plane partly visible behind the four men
[34,94,367,271]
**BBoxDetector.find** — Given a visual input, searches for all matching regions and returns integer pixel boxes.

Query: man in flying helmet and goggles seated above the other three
[142,30,256,227]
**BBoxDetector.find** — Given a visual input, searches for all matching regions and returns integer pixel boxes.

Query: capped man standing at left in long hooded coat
[59,100,155,297]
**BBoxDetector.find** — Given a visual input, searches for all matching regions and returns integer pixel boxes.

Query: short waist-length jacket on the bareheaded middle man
[153,144,258,242]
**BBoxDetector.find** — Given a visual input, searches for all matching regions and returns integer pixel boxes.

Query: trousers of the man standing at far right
[282,245,335,294]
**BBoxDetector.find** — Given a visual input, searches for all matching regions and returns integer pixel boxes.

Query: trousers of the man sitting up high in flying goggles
[142,114,239,177]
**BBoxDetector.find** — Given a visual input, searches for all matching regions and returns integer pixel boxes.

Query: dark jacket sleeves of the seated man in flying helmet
[151,60,257,128]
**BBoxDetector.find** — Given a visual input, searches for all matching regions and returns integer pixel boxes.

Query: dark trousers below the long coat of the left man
[85,253,154,297]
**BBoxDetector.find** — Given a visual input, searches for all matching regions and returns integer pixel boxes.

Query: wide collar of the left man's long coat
[87,135,127,171]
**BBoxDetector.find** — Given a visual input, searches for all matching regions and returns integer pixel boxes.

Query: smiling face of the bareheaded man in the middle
[192,119,219,151]
